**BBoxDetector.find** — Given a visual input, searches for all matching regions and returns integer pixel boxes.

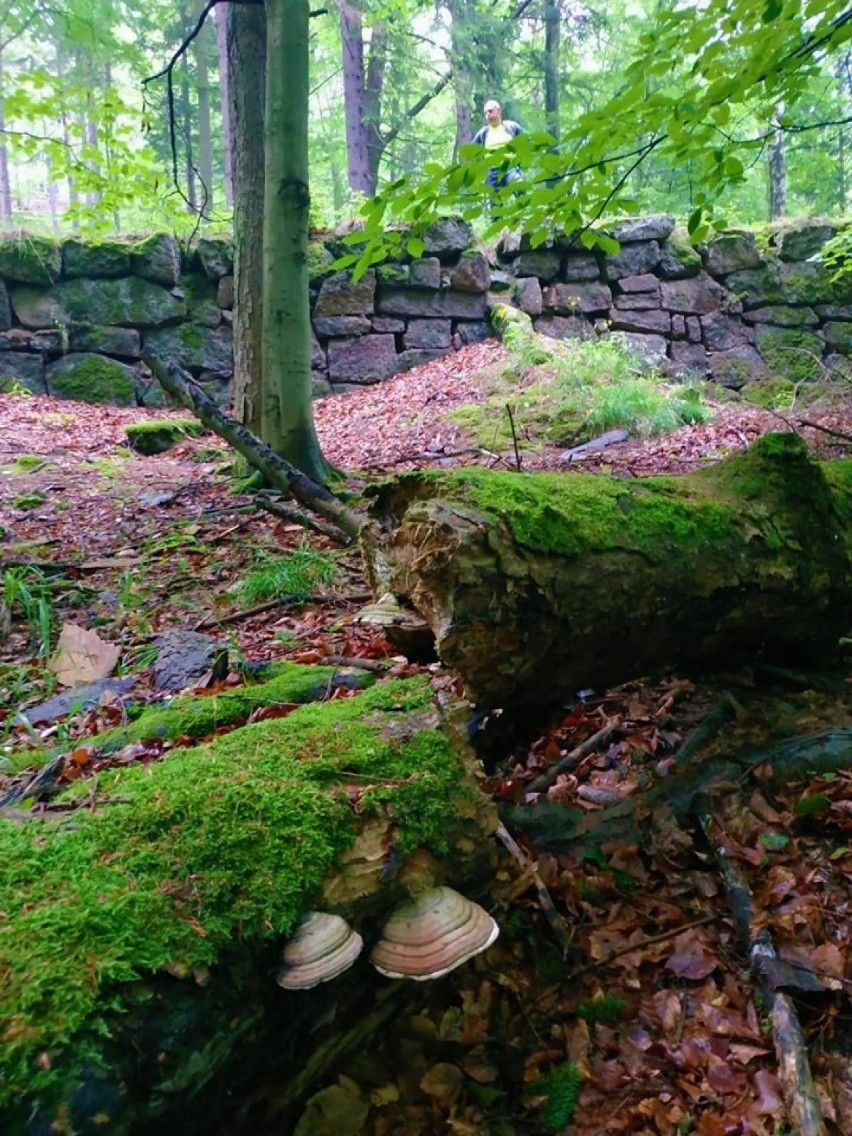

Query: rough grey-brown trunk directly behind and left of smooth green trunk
[225,3,266,436]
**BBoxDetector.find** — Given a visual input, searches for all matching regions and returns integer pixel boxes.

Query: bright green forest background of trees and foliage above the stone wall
[0,0,852,244]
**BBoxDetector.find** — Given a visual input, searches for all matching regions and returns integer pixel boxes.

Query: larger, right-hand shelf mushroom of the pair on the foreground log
[370,887,500,982]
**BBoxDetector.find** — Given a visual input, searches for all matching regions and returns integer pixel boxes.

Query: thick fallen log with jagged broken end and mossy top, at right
[361,434,852,708]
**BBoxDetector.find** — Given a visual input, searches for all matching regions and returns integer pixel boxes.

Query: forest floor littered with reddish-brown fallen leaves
[0,343,852,1136]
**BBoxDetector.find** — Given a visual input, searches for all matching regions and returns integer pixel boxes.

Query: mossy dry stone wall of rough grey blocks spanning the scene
[0,216,852,406]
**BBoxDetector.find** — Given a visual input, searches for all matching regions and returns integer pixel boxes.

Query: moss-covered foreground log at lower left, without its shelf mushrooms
[0,668,495,1134]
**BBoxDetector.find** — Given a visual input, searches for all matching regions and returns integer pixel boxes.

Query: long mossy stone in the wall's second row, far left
[11,276,186,328]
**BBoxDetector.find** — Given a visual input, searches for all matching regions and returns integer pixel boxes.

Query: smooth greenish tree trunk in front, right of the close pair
[260,0,328,484]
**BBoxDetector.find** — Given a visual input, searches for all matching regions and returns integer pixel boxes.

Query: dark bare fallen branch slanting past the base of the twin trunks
[142,351,361,544]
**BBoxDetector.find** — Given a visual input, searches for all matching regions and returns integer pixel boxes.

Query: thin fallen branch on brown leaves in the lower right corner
[695,796,826,1136]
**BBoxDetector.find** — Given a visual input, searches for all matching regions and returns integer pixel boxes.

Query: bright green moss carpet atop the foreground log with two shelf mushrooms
[0,679,474,1103]
